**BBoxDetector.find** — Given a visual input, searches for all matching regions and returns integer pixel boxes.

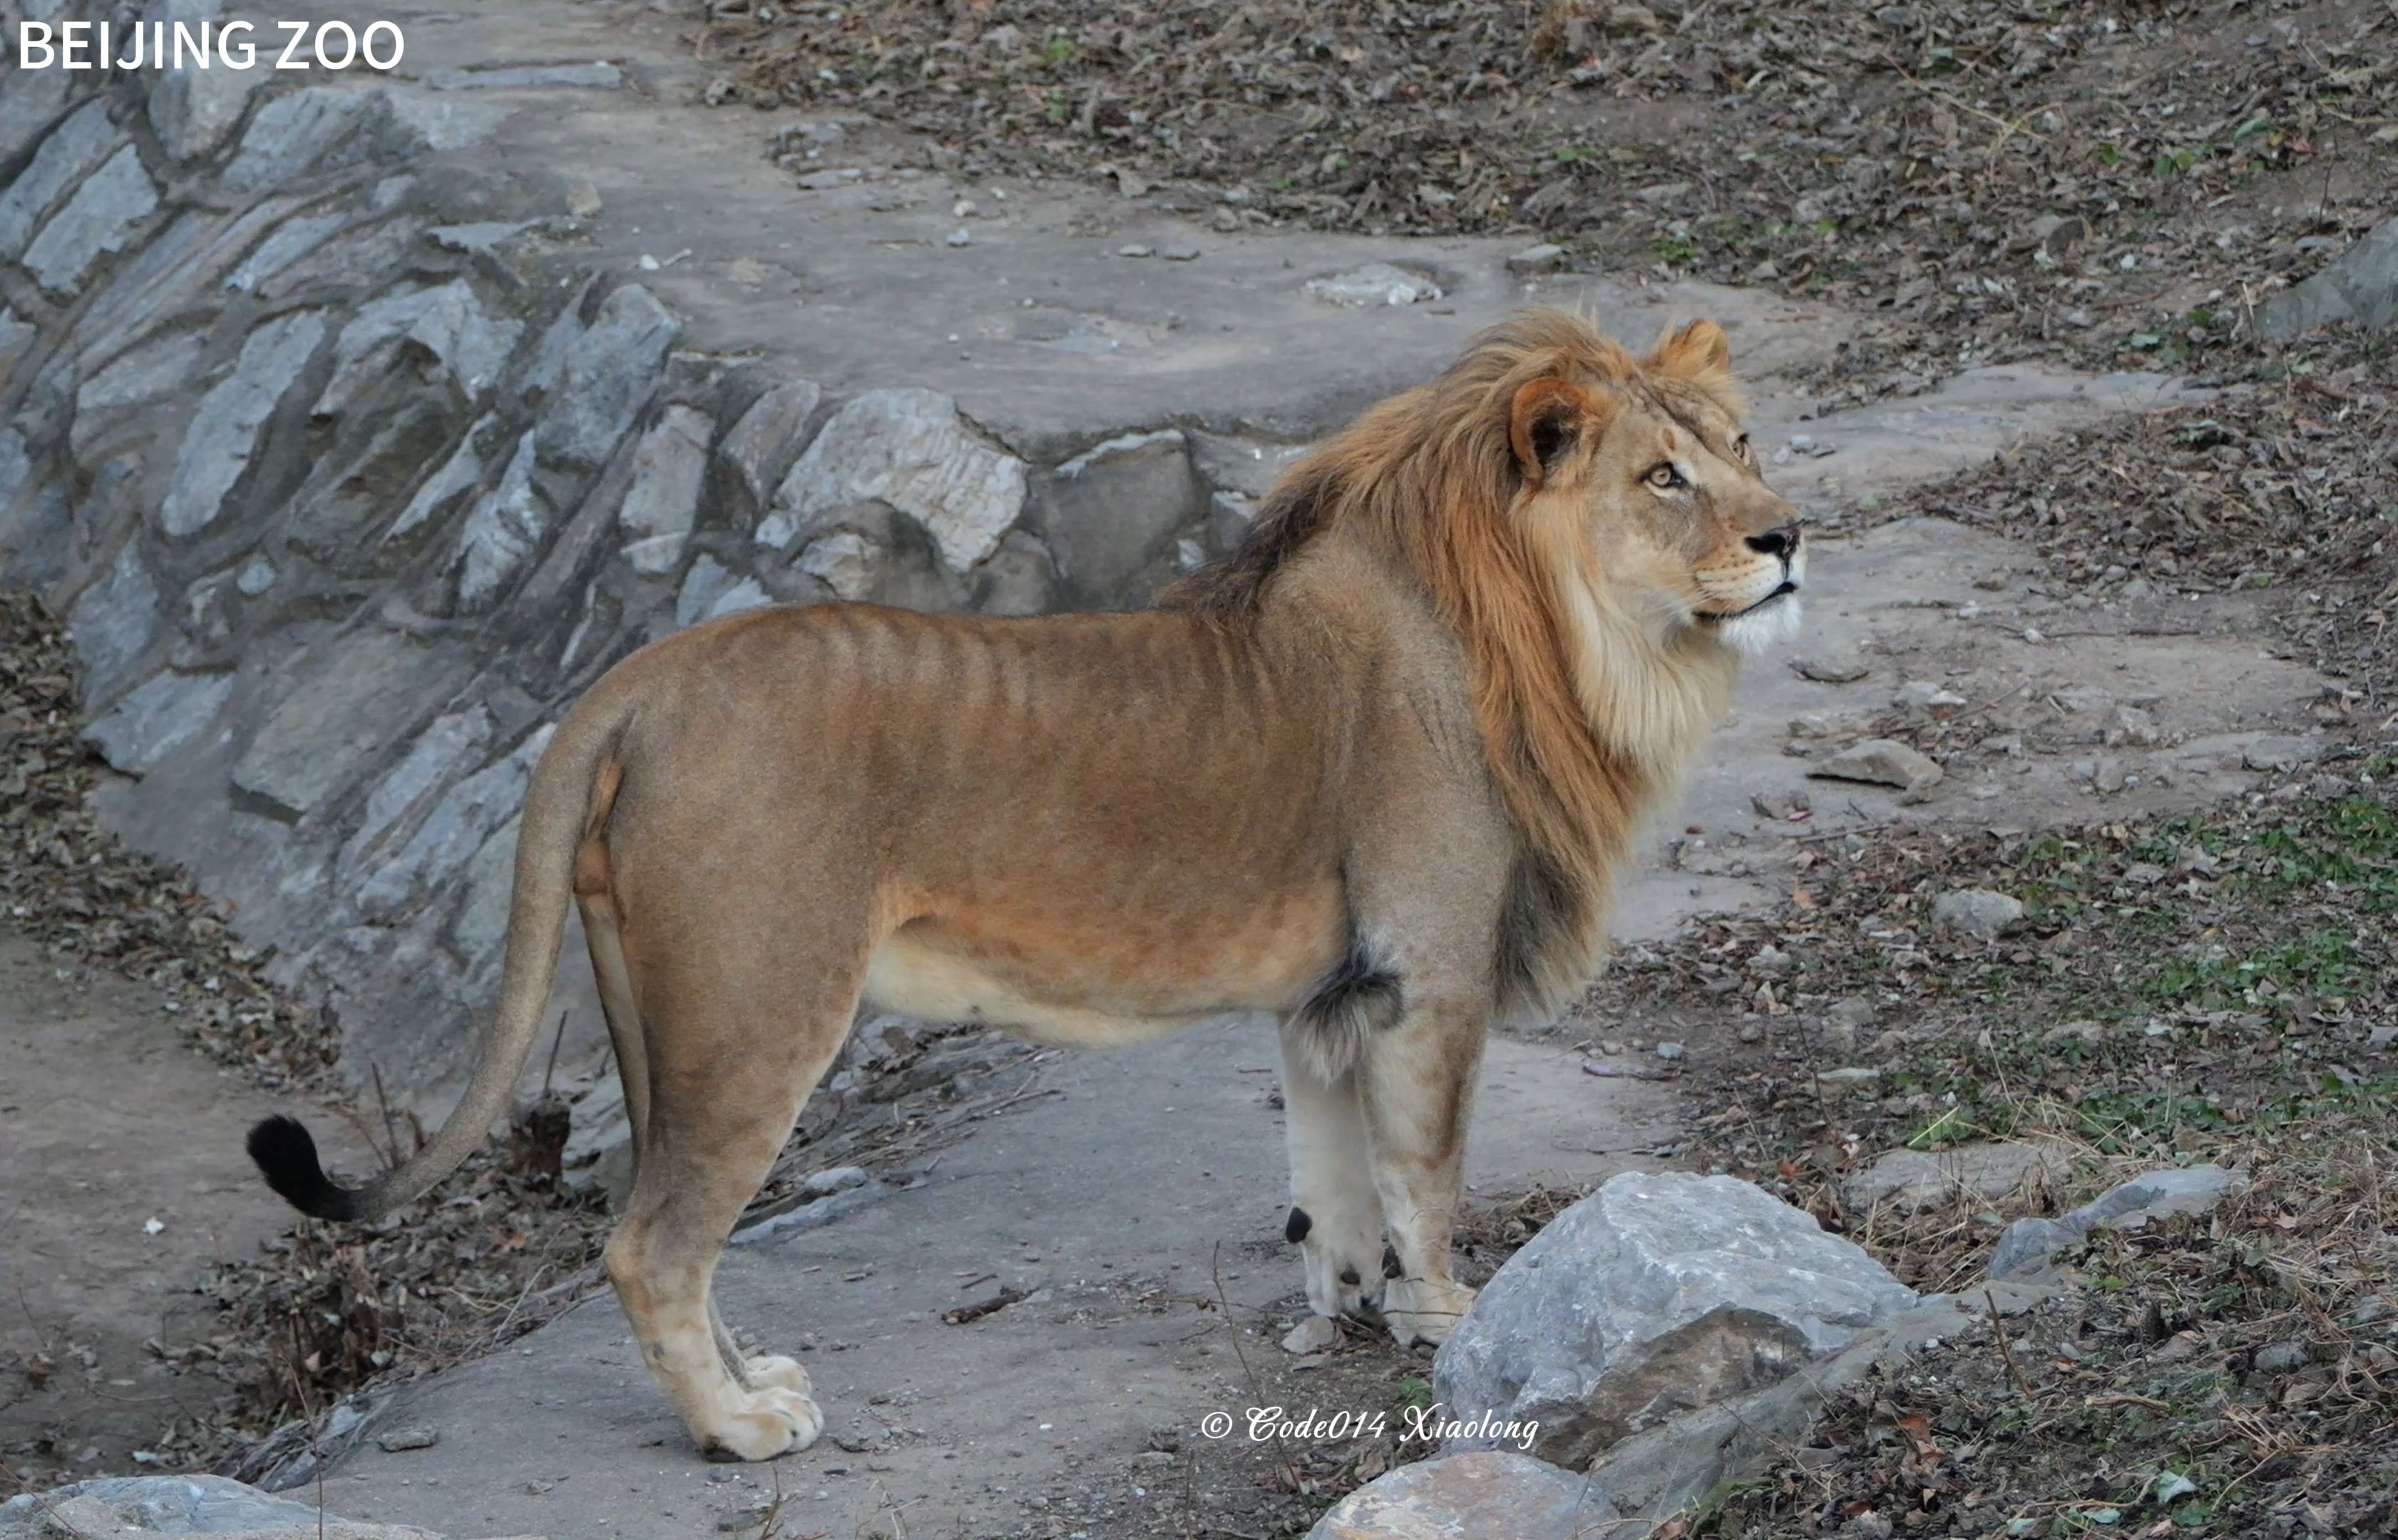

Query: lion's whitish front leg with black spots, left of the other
[1283,1027,1383,1317]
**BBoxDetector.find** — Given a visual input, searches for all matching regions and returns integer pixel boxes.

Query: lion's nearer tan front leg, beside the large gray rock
[1357,1002,1485,1345]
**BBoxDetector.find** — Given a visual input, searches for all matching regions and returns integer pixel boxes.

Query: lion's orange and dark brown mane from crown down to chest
[1158,309,1731,1015]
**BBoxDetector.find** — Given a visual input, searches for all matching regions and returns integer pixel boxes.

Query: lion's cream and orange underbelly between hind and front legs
[866,893,1348,1046]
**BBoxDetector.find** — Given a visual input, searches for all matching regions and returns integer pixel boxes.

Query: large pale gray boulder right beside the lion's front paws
[1432,1173,1916,1468]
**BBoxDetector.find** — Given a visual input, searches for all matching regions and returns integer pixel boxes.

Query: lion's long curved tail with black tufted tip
[250,700,630,1218]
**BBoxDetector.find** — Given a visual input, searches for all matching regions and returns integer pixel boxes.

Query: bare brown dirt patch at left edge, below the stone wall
[0,928,355,1485]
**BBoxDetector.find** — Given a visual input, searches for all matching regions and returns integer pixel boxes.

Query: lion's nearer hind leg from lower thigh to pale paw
[607,948,864,1461]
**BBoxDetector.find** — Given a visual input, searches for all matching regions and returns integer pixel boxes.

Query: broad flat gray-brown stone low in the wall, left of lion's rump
[232,628,470,818]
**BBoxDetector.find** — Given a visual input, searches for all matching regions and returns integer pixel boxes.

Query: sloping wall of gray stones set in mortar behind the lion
[0,0,1271,1101]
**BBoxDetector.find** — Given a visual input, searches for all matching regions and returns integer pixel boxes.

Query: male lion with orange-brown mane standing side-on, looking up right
[250,309,1805,1461]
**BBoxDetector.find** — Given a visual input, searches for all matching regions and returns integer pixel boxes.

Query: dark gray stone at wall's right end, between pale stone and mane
[1033,429,1209,605]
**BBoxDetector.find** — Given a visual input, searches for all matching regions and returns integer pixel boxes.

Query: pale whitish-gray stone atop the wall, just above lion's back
[774,389,1024,571]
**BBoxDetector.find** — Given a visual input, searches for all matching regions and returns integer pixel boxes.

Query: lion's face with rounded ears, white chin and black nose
[1518,322,1805,655]
